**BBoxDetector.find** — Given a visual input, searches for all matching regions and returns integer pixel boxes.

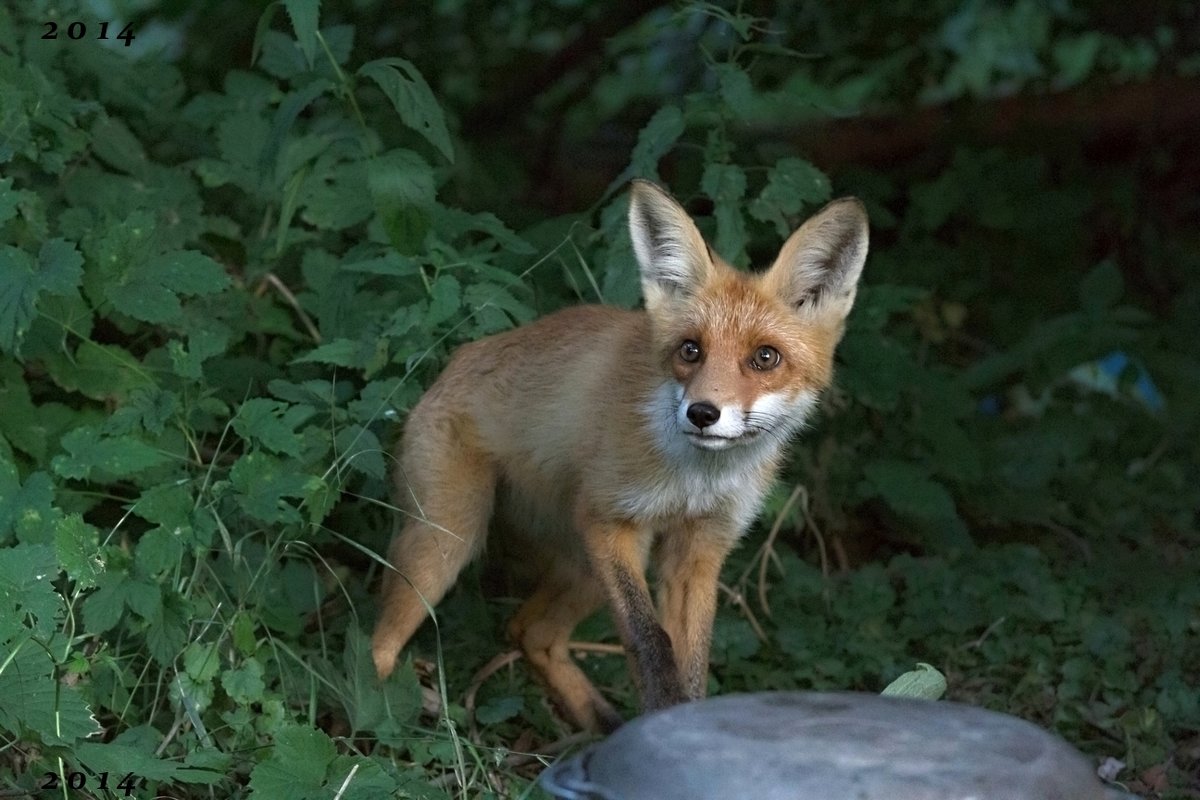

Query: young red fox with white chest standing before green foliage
[372,181,868,732]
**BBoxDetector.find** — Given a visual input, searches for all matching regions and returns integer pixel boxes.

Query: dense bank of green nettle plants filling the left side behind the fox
[0,4,552,796]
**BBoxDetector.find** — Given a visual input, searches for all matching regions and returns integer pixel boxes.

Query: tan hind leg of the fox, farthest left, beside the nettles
[371,407,496,678]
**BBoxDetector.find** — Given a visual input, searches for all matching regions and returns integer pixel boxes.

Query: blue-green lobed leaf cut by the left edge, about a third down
[0,239,83,353]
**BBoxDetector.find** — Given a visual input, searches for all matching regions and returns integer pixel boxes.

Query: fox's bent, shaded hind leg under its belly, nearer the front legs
[509,565,622,733]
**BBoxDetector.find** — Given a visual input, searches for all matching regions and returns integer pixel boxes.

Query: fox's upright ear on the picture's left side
[629,180,713,309]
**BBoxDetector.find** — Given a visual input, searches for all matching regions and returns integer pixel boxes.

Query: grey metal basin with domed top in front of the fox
[541,692,1130,800]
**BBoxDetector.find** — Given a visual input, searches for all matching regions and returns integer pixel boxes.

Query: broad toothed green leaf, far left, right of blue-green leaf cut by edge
[104,251,229,324]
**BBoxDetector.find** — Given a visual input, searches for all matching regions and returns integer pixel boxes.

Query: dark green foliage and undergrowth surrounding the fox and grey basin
[0,0,1200,799]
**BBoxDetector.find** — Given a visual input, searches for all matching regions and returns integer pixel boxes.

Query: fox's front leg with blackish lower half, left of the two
[583,522,688,711]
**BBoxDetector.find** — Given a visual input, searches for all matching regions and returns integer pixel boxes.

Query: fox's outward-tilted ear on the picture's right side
[763,198,870,318]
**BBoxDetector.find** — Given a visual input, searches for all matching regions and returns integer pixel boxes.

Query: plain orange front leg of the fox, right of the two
[656,521,737,699]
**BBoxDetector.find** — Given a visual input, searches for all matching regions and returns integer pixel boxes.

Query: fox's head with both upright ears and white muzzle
[629,180,868,450]
